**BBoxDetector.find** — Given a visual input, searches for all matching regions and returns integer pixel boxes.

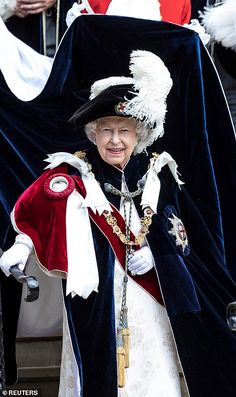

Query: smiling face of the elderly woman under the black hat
[95,116,137,168]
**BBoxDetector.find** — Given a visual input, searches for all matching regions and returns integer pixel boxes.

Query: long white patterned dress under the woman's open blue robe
[114,177,181,397]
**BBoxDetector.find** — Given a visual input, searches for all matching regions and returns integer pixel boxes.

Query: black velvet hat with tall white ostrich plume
[69,50,173,151]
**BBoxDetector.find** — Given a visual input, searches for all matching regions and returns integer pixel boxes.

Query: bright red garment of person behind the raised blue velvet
[89,0,191,25]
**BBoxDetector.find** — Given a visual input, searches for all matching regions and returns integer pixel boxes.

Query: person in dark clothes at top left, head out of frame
[0,0,74,57]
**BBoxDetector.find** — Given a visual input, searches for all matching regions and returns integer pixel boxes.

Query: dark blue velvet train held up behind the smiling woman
[0,16,236,397]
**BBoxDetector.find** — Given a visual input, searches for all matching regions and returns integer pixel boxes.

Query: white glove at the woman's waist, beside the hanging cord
[128,246,154,276]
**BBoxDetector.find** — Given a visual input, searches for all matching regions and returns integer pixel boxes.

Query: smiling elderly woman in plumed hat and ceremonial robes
[0,51,235,397]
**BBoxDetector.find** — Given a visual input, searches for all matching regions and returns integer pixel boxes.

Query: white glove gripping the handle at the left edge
[0,234,33,277]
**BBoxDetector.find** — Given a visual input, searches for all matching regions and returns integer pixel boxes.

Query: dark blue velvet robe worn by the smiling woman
[62,151,236,397]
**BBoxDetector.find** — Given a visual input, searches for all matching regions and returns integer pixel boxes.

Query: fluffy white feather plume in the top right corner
[200,0,236,51]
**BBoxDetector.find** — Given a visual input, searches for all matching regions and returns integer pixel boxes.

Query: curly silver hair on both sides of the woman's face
[84,119,153,155]
